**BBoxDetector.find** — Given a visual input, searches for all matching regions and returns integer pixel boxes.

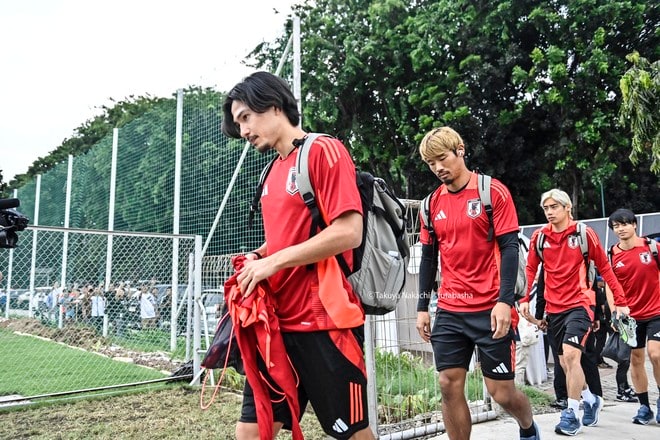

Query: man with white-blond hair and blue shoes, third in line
[520,189,628,435]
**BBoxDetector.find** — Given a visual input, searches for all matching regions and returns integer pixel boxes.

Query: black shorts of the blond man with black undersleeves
[431,310,516,380]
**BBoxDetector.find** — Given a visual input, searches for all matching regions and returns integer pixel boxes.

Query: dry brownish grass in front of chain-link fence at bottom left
[0,386,325,440]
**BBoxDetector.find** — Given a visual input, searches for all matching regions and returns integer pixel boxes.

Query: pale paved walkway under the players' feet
[432,360,660,440]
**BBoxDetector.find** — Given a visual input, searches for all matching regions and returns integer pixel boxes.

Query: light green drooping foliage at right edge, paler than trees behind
[619,51,660,174]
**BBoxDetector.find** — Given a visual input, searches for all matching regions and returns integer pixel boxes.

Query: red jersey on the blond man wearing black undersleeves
[419,173,518,312]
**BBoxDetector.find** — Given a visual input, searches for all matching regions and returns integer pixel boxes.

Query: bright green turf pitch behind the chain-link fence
[0,329,165,396]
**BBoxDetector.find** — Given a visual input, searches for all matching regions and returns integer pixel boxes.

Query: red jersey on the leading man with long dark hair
[261,137,364,331]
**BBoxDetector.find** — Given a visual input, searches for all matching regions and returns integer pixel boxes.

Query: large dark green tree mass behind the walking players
[253,0,659,223]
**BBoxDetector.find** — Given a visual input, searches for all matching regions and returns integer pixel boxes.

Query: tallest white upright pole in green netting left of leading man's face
[170,89,183,351]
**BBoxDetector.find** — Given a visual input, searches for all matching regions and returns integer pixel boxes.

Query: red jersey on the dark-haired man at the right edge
[612,238,660,321]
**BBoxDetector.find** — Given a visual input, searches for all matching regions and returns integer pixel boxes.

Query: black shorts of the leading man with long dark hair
[240,327,375,439]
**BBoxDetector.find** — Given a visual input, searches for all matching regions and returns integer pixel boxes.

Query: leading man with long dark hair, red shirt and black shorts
[222,72,375,440]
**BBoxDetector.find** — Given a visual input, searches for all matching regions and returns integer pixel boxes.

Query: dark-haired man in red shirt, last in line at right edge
[606,209,660,425]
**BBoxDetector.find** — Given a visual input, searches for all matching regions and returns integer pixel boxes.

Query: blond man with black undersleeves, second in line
[416,127,540,439]
